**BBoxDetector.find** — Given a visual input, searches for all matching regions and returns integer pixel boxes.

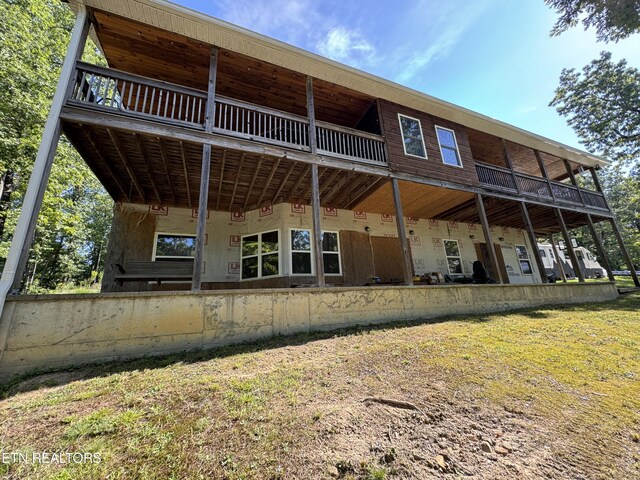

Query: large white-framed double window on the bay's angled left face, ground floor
[241,230,280,280]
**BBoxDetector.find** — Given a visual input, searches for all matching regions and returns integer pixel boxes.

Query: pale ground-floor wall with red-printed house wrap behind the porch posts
[109,203,541,291]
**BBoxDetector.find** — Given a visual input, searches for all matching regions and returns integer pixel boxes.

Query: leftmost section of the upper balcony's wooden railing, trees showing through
[70,62,207,125]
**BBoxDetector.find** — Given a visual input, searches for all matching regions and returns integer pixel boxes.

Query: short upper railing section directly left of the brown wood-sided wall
[316,122,387,165]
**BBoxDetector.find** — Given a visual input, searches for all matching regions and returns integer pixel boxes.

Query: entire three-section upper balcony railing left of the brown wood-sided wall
[69,62,387,166]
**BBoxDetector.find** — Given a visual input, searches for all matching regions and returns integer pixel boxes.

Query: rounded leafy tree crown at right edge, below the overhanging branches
[550,52,640,163]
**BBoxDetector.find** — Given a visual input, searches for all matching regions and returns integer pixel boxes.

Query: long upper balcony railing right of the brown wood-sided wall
[476,162,607,210]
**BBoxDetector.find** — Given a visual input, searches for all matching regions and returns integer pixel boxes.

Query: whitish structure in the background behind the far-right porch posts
[538,243,607,279]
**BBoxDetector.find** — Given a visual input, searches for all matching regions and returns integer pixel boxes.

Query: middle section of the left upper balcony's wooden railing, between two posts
[213,96,309,150]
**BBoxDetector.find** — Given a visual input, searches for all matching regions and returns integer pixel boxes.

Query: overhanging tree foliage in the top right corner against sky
[545,0,640,42]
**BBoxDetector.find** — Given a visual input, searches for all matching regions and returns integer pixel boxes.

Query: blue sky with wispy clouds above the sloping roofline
[172,0,640,152]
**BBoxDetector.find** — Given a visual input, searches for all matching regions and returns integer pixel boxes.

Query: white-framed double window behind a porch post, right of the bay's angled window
[291,229,342,275]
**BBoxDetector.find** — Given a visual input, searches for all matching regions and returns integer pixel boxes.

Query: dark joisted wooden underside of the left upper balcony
[63,122,384,212]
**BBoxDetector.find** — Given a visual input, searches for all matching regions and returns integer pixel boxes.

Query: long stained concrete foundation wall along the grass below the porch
[0,283,617,381]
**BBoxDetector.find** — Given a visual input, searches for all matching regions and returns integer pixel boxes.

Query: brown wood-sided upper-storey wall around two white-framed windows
[380,101,480,186]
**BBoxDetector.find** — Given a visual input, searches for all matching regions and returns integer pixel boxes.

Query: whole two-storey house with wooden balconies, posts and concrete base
[0,0,638,382]
